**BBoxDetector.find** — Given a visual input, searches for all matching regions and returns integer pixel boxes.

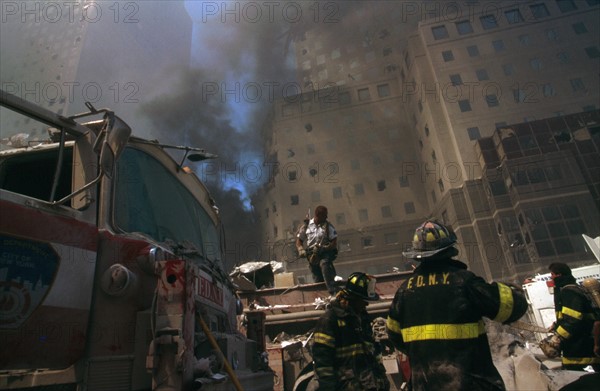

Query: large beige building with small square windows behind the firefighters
[258,0,600,282]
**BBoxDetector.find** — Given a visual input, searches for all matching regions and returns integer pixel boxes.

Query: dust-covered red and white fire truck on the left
[0,91,273,391]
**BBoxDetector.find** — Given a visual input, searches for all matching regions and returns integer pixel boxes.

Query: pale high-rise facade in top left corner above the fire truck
[0,0,89,139]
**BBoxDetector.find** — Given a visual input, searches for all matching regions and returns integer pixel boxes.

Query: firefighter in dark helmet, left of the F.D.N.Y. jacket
[312,272,390,391]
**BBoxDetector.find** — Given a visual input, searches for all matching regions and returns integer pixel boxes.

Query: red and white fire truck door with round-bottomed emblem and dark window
[0,142,98,370]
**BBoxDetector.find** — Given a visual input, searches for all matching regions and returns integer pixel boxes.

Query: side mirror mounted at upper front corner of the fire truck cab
[100,113,131,178]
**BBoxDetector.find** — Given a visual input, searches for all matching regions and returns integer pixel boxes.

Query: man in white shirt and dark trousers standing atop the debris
[296,205,338,297]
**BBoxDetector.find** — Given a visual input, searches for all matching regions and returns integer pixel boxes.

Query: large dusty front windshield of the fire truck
[113,148,220,260]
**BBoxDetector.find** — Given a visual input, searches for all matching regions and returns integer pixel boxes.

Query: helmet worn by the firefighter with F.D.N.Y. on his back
[402,220,456,259]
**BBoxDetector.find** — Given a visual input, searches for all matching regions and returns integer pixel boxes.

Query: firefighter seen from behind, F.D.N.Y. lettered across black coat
[387,220,527,391]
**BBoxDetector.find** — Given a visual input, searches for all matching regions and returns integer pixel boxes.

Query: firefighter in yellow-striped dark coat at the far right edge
[540,262,600,372]
